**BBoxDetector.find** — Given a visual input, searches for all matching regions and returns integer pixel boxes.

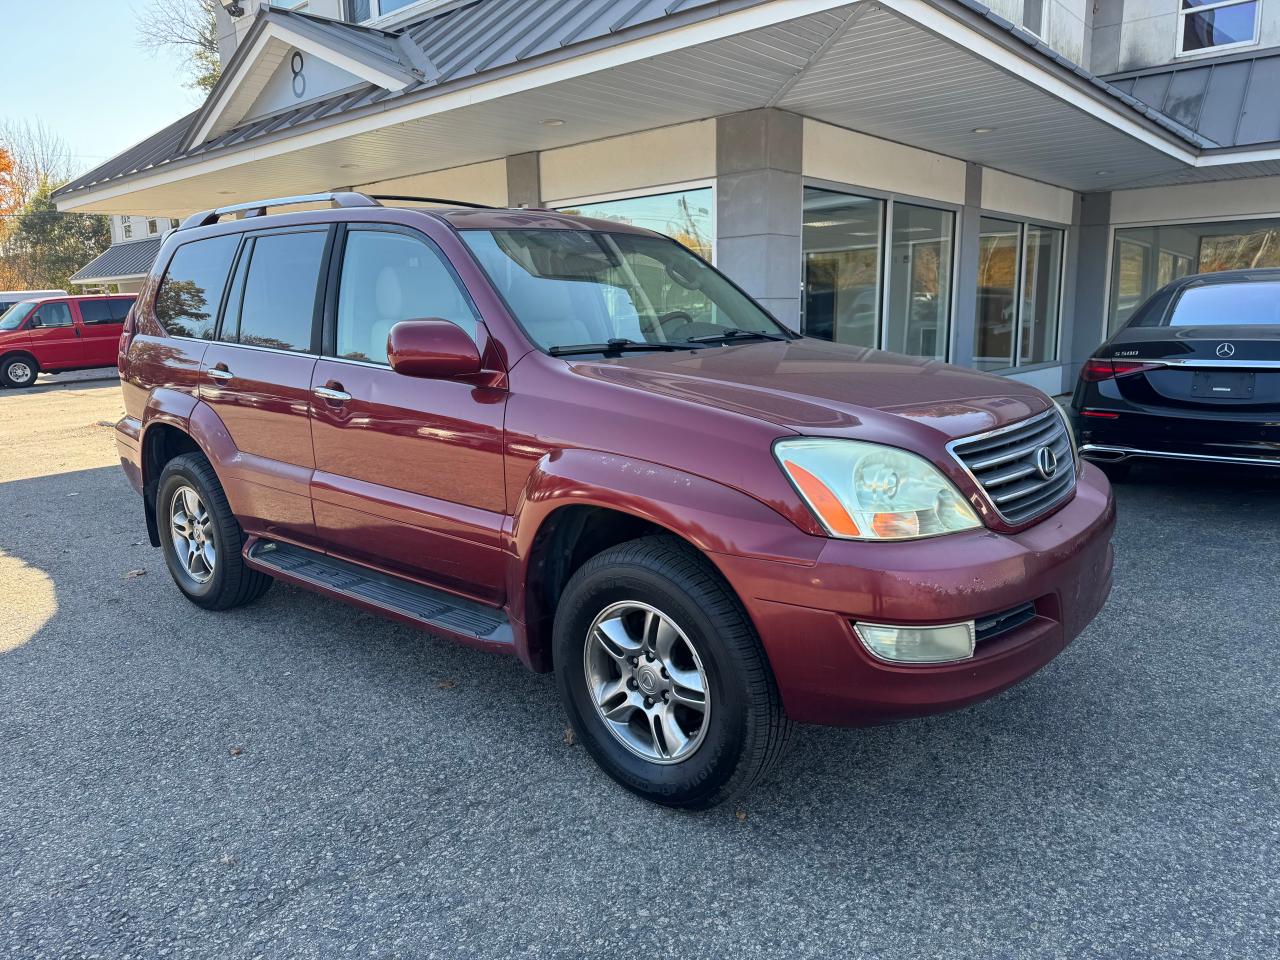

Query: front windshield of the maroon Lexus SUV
[462,230,790,352]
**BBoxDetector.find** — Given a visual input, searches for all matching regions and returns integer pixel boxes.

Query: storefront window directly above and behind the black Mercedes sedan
[1108,220,1280,332]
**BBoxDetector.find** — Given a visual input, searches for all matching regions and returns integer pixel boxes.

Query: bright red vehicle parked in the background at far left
[0,293,136,388]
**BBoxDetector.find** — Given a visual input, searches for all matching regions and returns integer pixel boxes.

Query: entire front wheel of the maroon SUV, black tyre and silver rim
[552,536,791,810]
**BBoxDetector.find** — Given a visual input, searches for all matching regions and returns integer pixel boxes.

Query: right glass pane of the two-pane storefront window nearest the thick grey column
[884,204,955,360]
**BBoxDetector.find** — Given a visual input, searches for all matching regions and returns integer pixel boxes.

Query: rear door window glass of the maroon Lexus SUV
[235,230,328,351]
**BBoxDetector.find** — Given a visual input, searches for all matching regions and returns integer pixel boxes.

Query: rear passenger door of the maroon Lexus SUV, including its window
[200,225,332,544]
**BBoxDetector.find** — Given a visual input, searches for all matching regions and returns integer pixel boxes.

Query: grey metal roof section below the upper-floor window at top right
[1107,49,1280,147]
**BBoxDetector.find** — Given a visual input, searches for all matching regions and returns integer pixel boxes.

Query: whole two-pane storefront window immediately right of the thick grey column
[804,187,955,360]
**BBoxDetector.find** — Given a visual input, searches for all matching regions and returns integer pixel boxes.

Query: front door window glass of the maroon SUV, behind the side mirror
[337,229,476,364]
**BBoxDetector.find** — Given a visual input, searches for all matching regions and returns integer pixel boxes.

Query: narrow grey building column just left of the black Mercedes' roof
[1062,193,1111,385]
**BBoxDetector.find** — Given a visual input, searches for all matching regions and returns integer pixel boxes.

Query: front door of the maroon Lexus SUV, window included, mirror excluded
[311,224,507,603]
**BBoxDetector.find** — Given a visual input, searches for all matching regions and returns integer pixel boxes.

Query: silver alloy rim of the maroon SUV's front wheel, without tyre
[584,600,710,763]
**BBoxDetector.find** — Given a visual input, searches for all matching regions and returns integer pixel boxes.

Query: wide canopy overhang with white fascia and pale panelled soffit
[56,0,1280,215]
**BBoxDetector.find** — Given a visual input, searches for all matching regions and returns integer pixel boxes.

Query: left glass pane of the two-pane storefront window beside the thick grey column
[804,187,884,347]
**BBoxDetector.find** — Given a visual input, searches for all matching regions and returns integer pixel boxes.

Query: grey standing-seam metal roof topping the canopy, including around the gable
[54,0,1249,204]
